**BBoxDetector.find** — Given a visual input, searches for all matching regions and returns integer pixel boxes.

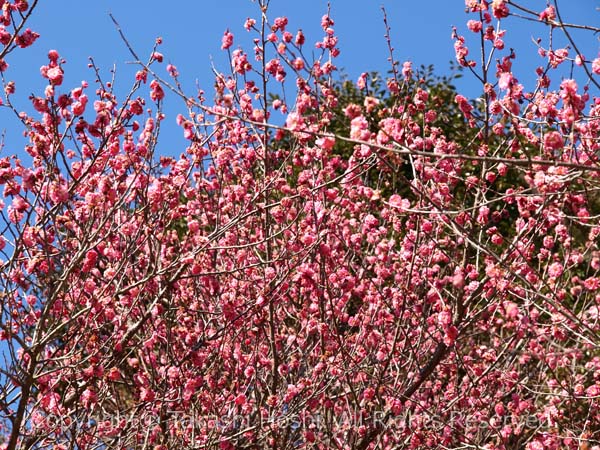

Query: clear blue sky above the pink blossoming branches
[0,0,600,153]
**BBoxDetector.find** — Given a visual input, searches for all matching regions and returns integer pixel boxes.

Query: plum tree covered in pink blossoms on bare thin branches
[0,0,600,450]
